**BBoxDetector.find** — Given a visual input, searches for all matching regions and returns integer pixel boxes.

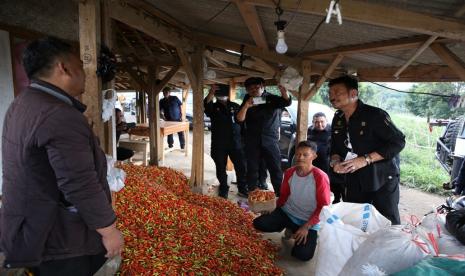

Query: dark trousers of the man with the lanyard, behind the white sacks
[347,177,400,225]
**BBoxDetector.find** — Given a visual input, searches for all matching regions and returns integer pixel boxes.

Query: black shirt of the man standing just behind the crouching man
[307,125,331,173]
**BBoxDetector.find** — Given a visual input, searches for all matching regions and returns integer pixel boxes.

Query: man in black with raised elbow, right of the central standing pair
[236,77,292,196]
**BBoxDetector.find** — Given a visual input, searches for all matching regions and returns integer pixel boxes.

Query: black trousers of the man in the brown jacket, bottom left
[28,253,107,276]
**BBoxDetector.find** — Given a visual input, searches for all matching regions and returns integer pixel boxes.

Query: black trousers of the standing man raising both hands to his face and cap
[245,143,283,196]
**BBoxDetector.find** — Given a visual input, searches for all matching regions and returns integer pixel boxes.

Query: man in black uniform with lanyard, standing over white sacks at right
[328,76,405,224]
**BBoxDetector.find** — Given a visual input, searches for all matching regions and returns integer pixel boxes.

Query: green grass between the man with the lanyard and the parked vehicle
[392,114,449,194]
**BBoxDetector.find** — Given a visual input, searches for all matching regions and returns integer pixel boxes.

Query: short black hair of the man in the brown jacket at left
[23,36,74,79]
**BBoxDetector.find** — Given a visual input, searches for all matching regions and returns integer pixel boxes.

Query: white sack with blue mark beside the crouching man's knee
[315,206,368,276]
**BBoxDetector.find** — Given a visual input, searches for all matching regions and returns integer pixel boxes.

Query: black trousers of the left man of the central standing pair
[211,147,247,195]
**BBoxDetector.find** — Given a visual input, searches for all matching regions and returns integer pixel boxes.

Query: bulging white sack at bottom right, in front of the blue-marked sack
[339,226,429,276]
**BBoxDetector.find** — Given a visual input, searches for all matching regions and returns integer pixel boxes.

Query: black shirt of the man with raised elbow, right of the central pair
[241,91,292,146]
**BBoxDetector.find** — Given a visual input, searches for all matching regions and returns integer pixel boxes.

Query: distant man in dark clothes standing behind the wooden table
[160,87,185,149]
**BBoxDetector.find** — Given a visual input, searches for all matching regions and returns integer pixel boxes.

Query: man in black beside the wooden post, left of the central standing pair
[203,84,247,198]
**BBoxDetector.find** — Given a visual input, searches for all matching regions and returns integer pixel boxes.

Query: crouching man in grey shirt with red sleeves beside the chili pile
[253,141,330,261]
